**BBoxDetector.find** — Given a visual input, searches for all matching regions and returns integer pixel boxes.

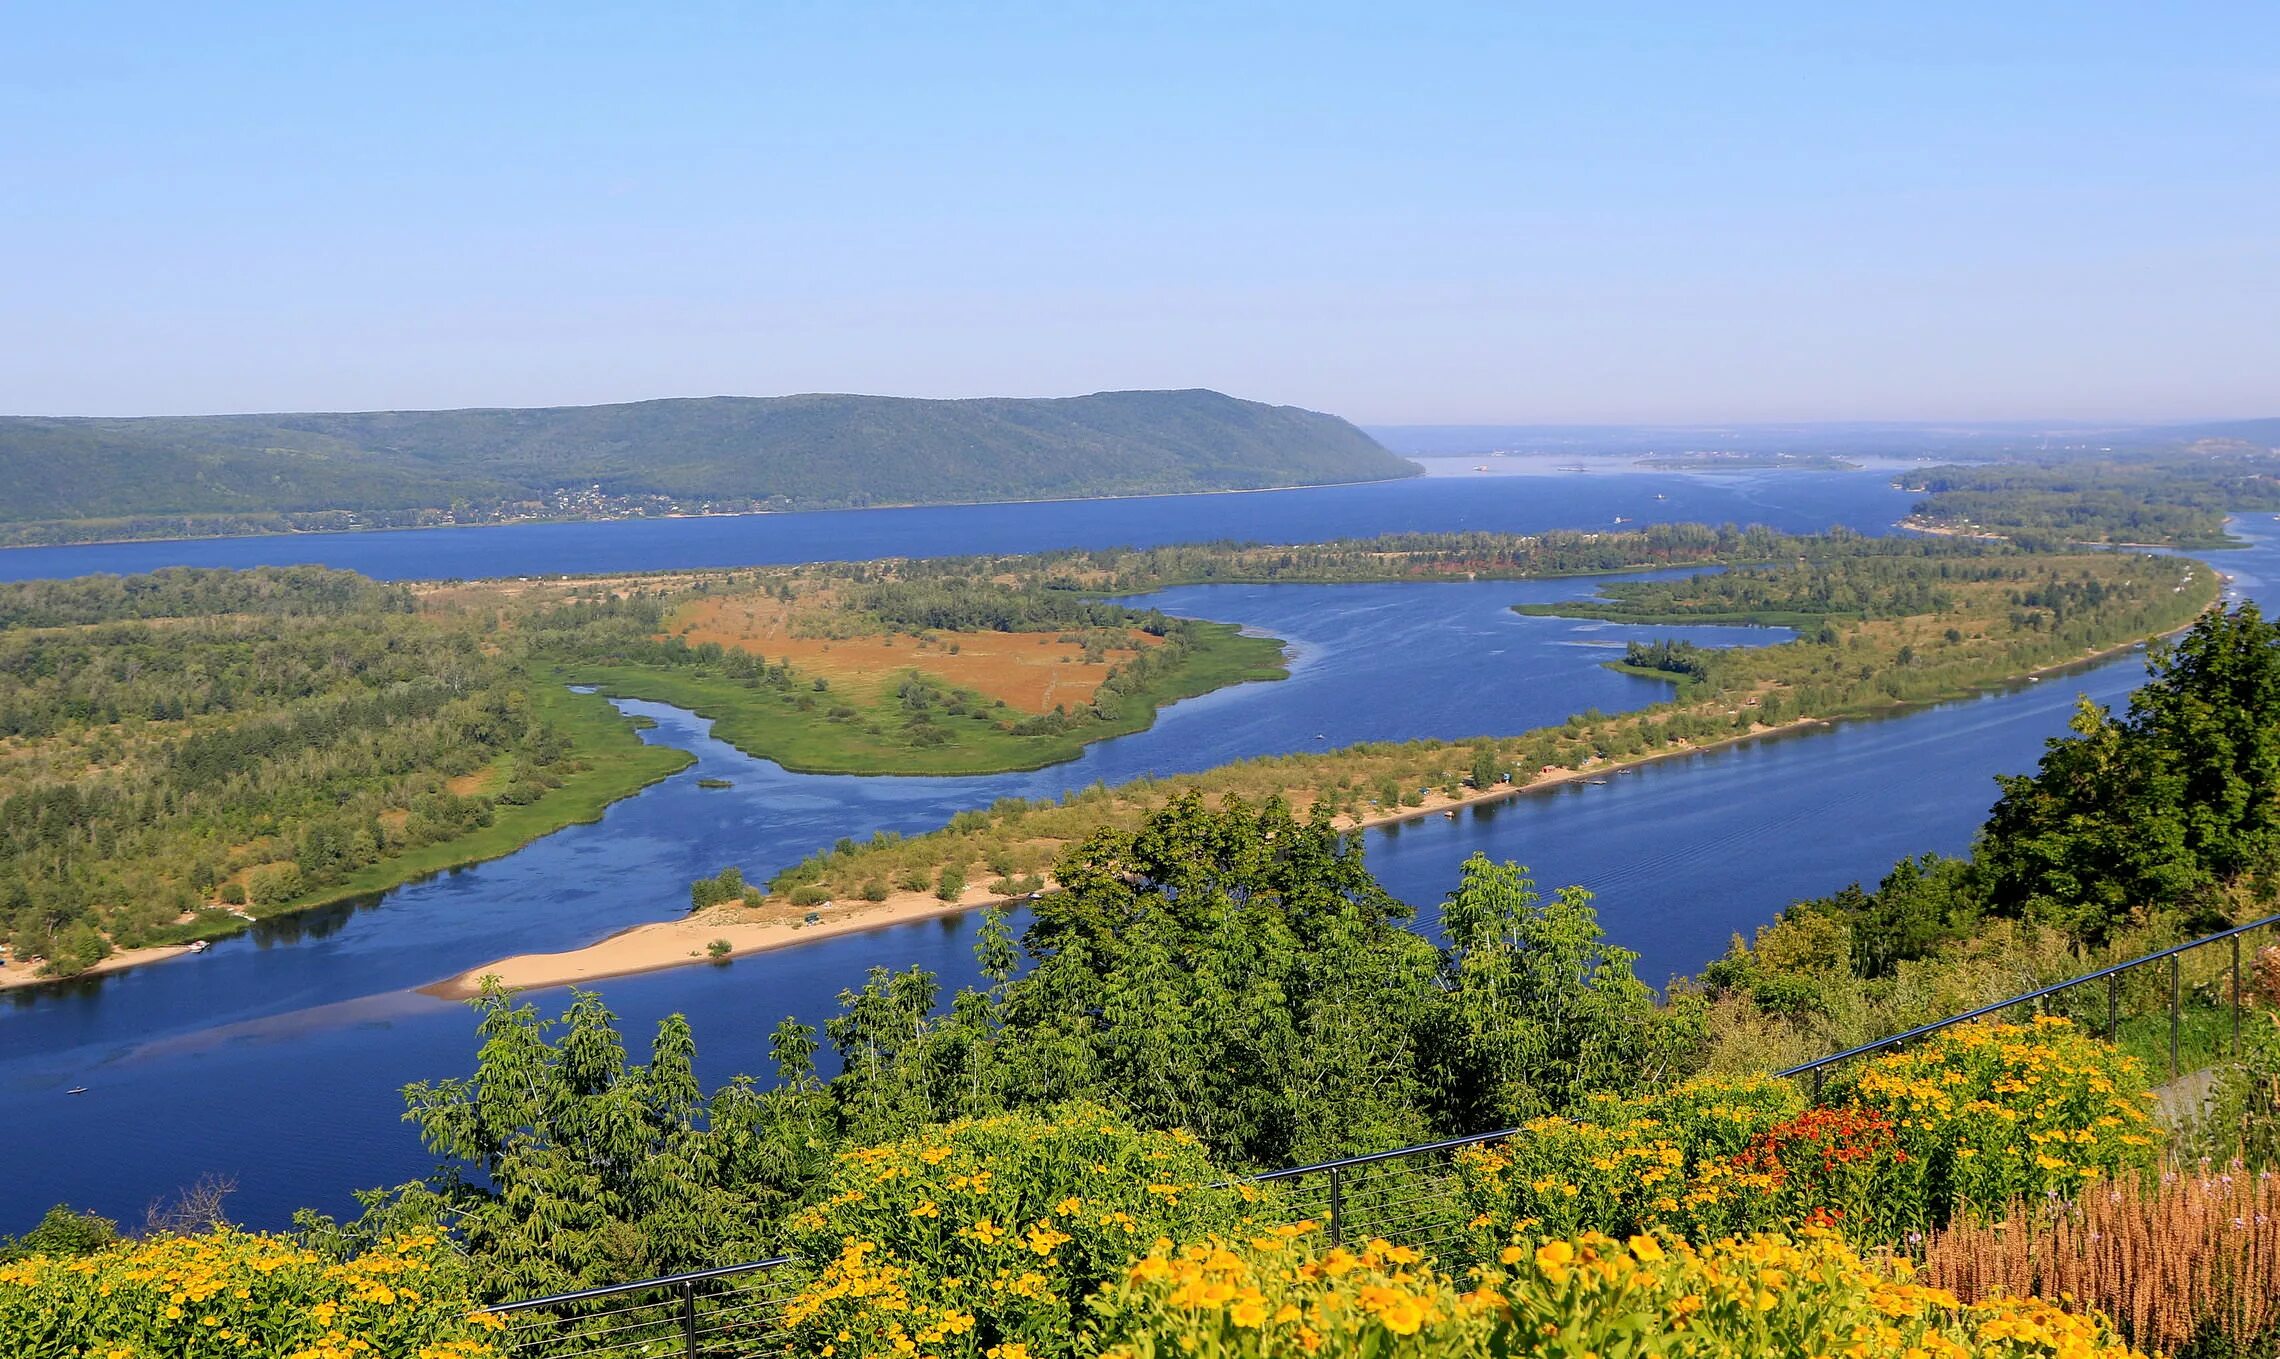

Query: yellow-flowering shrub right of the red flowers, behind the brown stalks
[1835,1017,2157,1227]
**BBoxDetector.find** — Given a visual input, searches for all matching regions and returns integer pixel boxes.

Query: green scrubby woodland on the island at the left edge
[0,568,597,974]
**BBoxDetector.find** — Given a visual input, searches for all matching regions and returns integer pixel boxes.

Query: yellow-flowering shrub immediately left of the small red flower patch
[1457,1079,1801,1250]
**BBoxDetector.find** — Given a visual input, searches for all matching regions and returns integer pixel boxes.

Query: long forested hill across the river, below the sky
[0,390,1416,540]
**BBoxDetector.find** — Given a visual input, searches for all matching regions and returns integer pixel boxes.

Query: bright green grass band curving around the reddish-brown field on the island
[559,622,1288,775]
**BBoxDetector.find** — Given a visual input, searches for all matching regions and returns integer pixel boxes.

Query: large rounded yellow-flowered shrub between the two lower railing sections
[787,1106,1256,1359]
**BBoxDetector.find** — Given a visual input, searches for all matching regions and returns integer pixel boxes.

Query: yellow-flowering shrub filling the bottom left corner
[0,1229,497,1359]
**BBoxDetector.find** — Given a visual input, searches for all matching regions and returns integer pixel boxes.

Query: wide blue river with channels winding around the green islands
[0,472,2280,1231]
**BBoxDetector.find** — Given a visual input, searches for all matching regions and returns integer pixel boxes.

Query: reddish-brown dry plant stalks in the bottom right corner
[1922,1163,2280,1352]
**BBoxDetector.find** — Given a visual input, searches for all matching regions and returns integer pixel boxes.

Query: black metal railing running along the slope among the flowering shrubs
[471,914,2280,1359]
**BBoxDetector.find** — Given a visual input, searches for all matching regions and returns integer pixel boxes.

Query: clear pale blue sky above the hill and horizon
[0,0,2280,424]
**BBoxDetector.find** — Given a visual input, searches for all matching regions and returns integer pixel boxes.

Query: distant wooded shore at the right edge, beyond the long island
[1902,451,2280,547]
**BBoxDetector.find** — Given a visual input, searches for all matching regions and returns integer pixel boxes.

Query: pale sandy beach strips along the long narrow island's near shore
[420,718,1826,999]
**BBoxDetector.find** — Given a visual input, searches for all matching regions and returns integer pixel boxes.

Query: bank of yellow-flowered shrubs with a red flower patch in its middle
[1457,1019,2155,1247]
